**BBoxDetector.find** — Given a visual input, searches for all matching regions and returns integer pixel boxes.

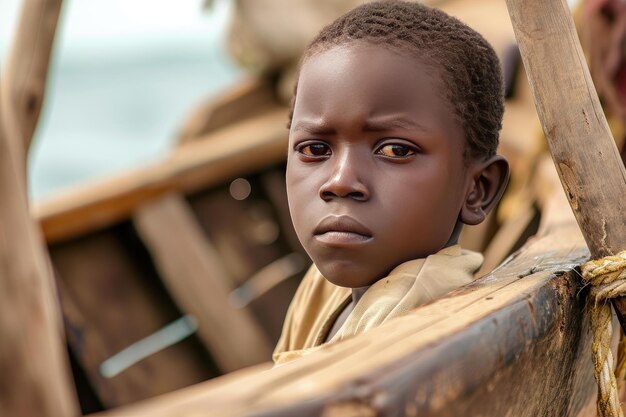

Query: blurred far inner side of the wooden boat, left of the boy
[35,102,298,408]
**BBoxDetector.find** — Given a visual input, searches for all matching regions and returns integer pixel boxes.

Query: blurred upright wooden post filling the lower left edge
[0,101,78,417]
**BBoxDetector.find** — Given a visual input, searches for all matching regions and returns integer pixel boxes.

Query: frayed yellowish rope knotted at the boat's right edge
[582,251,626,417]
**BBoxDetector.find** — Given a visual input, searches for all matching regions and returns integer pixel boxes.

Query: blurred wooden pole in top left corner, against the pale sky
[0,0,62,154]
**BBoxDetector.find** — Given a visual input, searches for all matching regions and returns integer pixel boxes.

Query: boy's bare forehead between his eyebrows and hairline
[294,42,456,127]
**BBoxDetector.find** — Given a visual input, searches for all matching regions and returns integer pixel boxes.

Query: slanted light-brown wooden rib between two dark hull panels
[134,194,271,372]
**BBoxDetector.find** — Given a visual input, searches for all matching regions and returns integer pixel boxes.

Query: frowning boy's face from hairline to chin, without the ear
[287,42,471,288]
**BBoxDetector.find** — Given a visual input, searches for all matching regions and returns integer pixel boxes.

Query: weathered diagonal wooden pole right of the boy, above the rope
[506,0,626,332]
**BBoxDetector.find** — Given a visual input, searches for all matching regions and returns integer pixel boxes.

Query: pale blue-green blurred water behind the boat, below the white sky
[29,40,239,199]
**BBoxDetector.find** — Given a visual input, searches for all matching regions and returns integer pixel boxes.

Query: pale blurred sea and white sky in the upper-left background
[0,0,241,200]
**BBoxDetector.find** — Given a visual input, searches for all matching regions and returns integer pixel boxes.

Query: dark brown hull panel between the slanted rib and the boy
[187,176,308,344]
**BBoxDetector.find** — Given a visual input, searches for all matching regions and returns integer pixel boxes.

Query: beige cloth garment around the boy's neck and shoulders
[273,245,483,365]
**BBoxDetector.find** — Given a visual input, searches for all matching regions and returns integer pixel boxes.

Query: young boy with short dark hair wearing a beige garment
[274,1,509,364]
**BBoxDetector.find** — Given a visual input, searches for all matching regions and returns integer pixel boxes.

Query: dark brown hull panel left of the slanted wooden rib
[50,223,214,408]
